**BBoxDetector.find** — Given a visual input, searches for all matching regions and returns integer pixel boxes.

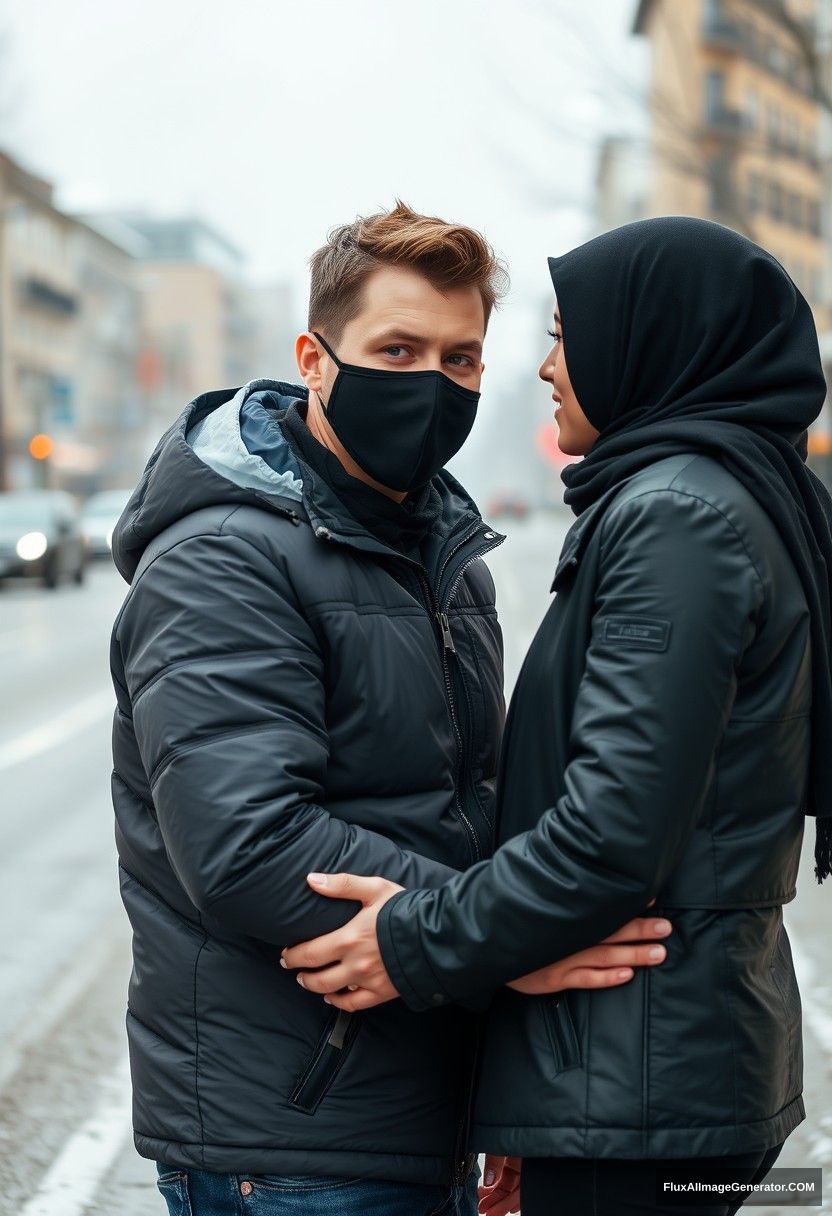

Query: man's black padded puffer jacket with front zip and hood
[112,382,504,1183]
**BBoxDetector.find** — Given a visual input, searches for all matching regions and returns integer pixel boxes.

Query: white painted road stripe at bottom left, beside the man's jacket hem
[19,1057,131,1216]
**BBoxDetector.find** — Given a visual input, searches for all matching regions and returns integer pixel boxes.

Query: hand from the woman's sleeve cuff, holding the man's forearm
[280,874,404,1013]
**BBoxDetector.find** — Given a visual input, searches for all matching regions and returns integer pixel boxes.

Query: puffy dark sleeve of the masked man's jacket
[118,530,456,947]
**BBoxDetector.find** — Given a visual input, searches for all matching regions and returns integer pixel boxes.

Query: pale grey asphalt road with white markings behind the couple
[0,513,832,1216]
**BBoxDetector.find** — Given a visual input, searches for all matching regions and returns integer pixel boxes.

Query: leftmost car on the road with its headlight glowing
[0,490,88,587]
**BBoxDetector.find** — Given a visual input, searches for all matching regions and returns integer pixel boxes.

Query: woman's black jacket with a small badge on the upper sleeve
[378,454,811,1158]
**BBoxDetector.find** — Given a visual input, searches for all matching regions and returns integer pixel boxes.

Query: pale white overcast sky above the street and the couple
[0,0,643,491]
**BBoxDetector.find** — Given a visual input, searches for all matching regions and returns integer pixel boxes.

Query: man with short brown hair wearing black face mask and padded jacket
[112,204,671,1216]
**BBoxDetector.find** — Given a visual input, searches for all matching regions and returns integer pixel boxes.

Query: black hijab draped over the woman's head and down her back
[549,216,832,883]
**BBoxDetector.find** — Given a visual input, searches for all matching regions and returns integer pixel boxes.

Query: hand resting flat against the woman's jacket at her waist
[508,900,673,996]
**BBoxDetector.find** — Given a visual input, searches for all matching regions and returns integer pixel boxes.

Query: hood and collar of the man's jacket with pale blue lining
[112,378,486,582]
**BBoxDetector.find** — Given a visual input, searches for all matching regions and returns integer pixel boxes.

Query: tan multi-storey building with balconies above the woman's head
[634,0,832,463]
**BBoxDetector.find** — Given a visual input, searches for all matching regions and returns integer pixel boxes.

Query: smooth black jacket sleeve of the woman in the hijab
[378,489,764,1010]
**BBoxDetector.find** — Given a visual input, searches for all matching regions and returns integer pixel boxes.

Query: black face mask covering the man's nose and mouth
[313,331,479,490]
